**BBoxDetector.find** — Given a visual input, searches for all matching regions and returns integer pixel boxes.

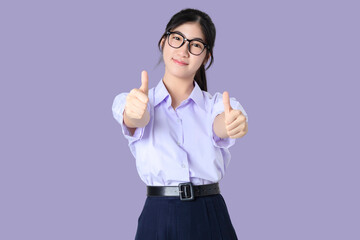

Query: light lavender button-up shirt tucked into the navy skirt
[112,79,248,186]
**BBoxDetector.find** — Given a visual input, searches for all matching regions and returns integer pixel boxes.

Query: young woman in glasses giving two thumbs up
[112,9,248,240]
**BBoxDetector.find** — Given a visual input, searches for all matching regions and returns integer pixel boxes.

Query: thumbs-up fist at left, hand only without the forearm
[125,70,149,120]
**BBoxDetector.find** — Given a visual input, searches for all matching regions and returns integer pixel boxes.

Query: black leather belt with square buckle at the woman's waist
[146,182,220,201]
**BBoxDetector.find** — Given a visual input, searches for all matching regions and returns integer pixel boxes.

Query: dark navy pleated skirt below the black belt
[135,194,238,240]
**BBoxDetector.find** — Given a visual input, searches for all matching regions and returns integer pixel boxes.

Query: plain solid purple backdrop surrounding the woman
[0,0,360,240]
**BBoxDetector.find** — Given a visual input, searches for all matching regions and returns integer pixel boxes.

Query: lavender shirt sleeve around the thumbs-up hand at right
[211,92,248,148]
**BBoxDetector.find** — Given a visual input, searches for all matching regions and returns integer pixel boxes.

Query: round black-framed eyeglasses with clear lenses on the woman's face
[166,32,209,56]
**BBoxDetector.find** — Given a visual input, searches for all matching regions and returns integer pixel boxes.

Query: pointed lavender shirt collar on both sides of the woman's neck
[154,78,206,111]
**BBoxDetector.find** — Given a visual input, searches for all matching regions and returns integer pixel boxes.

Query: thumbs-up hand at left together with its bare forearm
[124,70,150,128]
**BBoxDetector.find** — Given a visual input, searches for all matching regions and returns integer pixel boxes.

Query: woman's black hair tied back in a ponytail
[157,8,216,91]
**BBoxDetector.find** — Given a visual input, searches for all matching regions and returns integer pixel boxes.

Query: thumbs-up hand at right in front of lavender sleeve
[223,91,248,138]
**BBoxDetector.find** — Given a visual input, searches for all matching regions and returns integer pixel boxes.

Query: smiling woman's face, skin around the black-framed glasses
[161,22,208,79]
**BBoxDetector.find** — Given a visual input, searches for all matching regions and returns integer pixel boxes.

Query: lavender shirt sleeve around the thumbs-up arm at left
[112,93,150,145]
